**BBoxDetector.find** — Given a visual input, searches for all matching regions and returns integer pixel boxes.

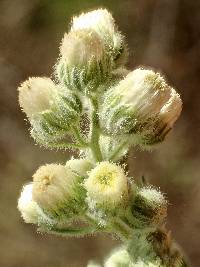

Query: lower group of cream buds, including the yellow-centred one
[18,158,167,237]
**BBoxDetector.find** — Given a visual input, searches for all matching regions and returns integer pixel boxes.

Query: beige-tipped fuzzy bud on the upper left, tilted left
[19,78,81,146]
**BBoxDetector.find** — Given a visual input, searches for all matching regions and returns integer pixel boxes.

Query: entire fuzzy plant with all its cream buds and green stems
[18,9,182,267]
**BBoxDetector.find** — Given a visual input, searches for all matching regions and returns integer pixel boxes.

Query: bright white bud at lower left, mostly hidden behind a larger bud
[18,184,39,224]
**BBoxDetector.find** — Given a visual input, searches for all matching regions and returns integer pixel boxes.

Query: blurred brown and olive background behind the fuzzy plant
[0,0,200,267]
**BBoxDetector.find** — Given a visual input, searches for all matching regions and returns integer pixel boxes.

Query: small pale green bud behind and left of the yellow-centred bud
[65,158,93,177]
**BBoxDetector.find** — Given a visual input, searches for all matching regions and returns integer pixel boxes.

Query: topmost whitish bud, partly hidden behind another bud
[71,9,127,66]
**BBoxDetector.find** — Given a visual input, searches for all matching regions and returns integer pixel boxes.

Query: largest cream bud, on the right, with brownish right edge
[99,69,182,145]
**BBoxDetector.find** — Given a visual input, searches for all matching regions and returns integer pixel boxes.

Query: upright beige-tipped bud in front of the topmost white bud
[56,29,111,92]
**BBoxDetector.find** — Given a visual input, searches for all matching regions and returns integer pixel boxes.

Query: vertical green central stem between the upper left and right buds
[90,97,102,162]
